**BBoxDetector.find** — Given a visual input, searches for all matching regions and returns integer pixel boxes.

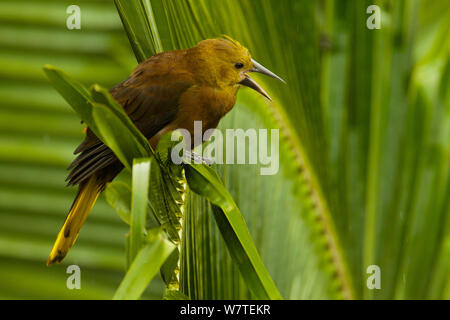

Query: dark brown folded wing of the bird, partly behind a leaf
[67,59,193,185]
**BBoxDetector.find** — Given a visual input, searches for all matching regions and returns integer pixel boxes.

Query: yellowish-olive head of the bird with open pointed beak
[194,36,285,100]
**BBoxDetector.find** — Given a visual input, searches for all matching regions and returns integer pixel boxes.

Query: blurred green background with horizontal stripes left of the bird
[0,0,161,299]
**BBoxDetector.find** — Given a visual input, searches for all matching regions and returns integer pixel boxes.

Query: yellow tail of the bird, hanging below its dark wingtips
[47,176,101,266]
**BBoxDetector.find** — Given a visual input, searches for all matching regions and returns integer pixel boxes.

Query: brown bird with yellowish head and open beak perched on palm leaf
[47,36,285,266]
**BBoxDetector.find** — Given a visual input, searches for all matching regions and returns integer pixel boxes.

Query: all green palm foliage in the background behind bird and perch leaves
[0,0,450,299]
